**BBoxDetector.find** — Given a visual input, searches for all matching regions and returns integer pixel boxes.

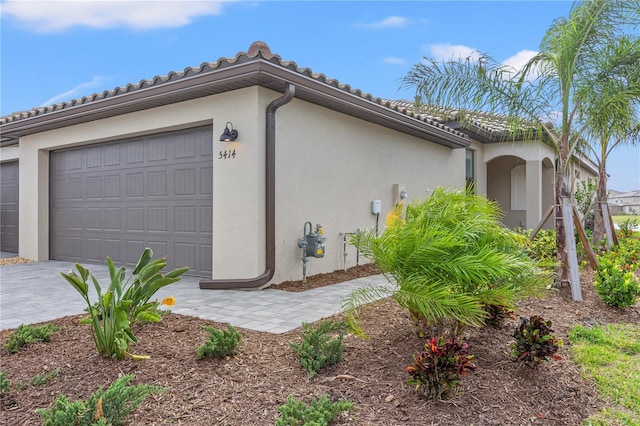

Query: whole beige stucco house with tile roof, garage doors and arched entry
[0,42,596,289]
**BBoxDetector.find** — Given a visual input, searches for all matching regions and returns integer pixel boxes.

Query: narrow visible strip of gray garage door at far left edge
[0,161,18,253]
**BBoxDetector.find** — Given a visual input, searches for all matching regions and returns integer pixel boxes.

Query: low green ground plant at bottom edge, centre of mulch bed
[276,395,355,426]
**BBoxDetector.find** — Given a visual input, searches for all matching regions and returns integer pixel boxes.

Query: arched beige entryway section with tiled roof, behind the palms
[392,101,598,229]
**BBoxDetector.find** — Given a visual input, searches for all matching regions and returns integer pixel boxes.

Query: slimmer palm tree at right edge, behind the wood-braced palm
[580,37,640,245]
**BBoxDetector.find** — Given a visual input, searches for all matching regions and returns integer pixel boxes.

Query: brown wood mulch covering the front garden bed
[0,269,640,426]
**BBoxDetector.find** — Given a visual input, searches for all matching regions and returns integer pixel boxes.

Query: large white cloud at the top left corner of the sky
[1,0,230,33]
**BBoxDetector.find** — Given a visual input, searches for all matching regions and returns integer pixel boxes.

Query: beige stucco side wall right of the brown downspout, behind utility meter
[272,94,465,283]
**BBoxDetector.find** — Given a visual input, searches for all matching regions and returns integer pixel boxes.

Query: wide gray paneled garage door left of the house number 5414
[50,126,213,277]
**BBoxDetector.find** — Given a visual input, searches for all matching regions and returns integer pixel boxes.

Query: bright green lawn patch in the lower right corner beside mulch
[569,324,640,426]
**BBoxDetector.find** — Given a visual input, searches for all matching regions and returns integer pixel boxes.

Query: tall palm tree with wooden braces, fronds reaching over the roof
[402,0,640,281]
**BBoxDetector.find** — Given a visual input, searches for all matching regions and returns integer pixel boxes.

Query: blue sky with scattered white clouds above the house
[0,0,640,191]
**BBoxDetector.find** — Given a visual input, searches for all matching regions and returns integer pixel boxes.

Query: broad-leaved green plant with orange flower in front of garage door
[61,248,189,359]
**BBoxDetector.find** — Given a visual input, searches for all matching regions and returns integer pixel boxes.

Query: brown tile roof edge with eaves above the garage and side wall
[0,42,470,148]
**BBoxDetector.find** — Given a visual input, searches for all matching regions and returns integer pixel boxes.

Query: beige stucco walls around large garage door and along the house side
[12,87,465,283]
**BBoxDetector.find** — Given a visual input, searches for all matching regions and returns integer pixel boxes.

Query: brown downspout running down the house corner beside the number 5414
[200,83,296,290]
